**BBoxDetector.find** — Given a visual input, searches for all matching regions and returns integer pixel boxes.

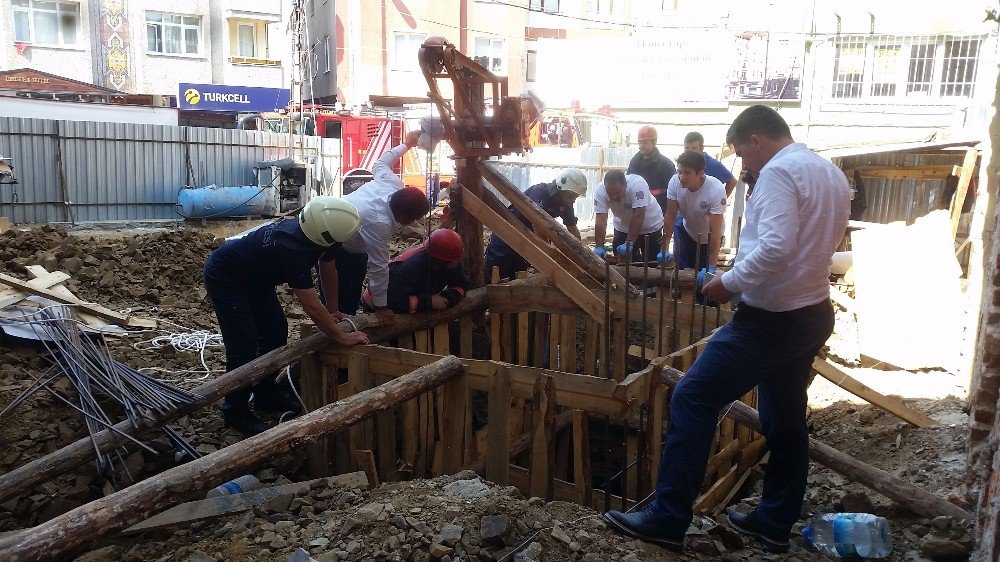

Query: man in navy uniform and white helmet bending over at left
[205,196,368,435]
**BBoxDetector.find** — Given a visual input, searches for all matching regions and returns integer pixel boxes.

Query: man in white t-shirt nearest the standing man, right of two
[661,150,726,287]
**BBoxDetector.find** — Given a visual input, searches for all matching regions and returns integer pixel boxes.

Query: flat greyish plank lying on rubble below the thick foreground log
[123,472,368,534]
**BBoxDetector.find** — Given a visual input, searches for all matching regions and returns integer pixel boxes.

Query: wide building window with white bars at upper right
[830,35,983,103]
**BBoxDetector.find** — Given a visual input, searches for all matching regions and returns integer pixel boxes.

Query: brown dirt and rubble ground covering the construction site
[0,223,972,562]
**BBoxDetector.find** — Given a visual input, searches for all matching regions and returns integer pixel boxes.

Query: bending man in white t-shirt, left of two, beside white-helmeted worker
[594,170,663,262]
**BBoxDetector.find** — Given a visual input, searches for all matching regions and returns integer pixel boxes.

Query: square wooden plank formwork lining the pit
[301,278,763,512]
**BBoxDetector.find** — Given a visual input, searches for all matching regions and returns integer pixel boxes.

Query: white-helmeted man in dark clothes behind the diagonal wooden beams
[484,168,587,281]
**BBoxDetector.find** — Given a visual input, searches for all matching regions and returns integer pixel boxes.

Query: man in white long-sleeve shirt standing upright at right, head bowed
[605,105,850,552]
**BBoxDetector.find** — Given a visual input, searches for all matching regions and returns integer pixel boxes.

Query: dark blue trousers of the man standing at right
[654,300,833,537]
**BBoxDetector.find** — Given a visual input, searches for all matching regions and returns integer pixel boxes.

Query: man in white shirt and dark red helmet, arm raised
[326,131,429,324]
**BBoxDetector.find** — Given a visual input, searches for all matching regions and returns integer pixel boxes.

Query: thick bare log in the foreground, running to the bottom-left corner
[0,355,462,562]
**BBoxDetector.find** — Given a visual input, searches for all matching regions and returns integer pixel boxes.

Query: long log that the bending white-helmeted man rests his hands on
[0,284,496,502]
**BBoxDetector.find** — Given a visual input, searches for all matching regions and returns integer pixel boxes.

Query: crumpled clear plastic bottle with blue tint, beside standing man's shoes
[802,513,892,558]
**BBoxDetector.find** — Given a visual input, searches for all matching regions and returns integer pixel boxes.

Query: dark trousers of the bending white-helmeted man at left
[205,265,288,410]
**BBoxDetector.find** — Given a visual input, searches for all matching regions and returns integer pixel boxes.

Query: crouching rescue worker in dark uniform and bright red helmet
[363,228,472,314]
